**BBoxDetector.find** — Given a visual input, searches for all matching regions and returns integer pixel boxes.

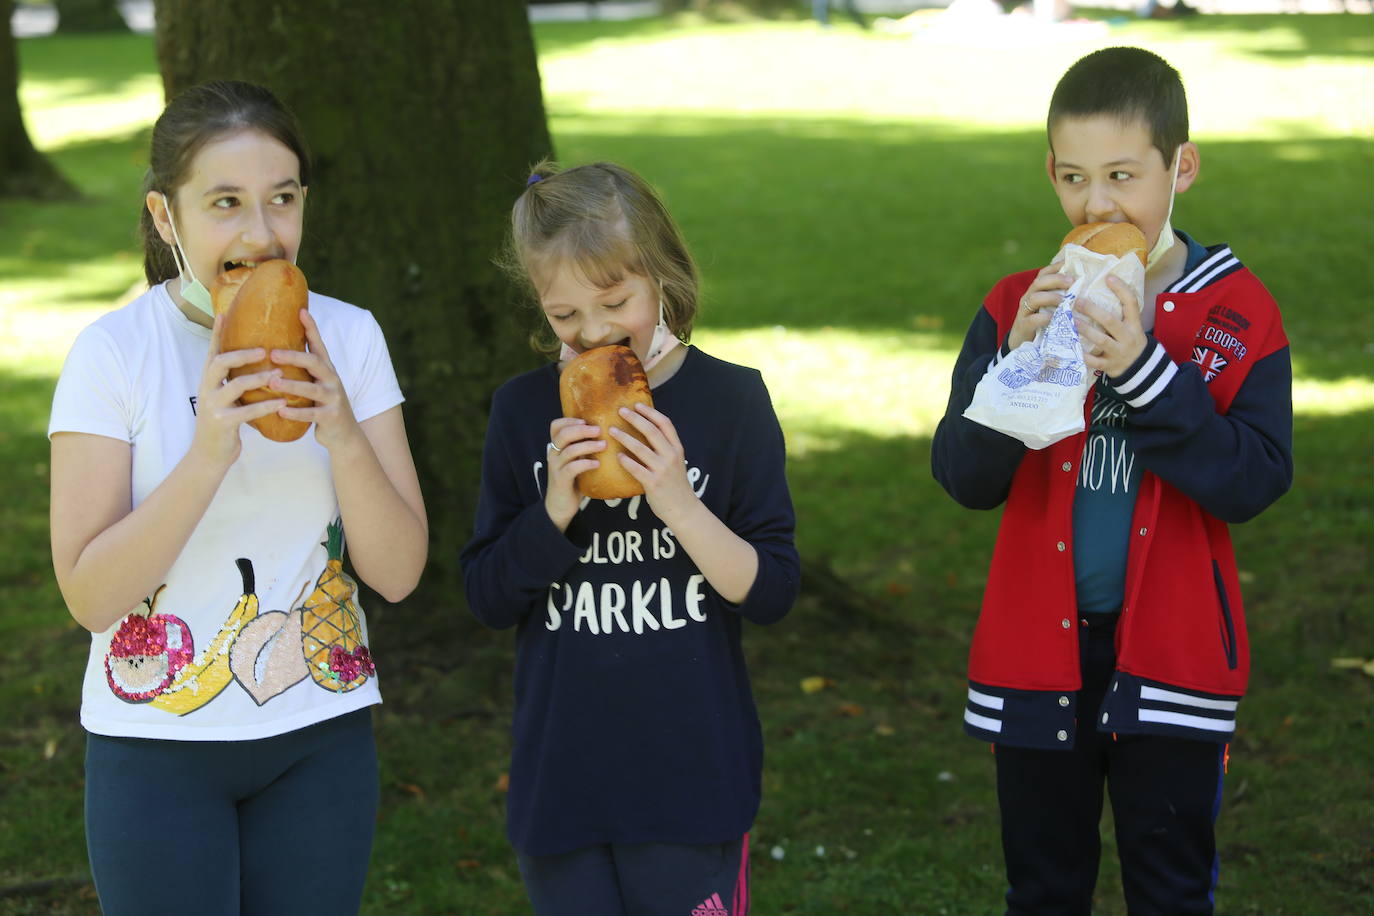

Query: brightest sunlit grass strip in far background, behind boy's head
[540,22,1374,139]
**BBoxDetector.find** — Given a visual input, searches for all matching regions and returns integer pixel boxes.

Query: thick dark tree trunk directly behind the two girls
[157,0,551,621]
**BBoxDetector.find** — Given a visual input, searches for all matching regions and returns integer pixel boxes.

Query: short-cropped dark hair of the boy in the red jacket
[1046,48,1189,166]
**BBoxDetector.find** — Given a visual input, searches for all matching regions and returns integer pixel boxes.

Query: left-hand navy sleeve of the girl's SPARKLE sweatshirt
[459,391,581,629]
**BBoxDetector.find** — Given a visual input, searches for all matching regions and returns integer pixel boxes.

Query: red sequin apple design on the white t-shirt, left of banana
[104,585,195,703]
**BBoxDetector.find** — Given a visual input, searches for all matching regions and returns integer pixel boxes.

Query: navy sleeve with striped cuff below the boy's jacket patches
[1107,338,1293,523]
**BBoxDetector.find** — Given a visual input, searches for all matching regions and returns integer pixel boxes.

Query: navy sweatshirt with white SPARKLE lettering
[460,347,798,856]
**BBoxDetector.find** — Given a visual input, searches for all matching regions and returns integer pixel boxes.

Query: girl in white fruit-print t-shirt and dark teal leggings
[48,82,427,916]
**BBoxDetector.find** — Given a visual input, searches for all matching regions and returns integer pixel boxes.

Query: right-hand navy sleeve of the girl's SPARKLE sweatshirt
[721,374,801,623]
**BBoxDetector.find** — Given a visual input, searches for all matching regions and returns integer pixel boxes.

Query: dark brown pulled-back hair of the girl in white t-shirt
[139,80,311,286]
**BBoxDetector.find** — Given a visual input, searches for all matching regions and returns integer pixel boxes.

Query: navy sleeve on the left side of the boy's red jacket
[930,308,1026,509]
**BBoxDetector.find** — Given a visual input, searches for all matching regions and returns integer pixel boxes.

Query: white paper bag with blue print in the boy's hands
[963,244,1145,449]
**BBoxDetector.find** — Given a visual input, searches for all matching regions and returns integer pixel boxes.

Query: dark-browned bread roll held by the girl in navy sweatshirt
[558,346,654,500]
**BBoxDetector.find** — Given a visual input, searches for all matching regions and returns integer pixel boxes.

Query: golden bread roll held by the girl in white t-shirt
[210,258,315,442]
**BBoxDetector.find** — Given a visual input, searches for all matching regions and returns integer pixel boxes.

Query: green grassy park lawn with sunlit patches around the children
[0,14,1374,916]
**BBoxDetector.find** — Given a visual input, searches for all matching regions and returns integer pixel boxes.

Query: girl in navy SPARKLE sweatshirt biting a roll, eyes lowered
[462,162,798,916]
